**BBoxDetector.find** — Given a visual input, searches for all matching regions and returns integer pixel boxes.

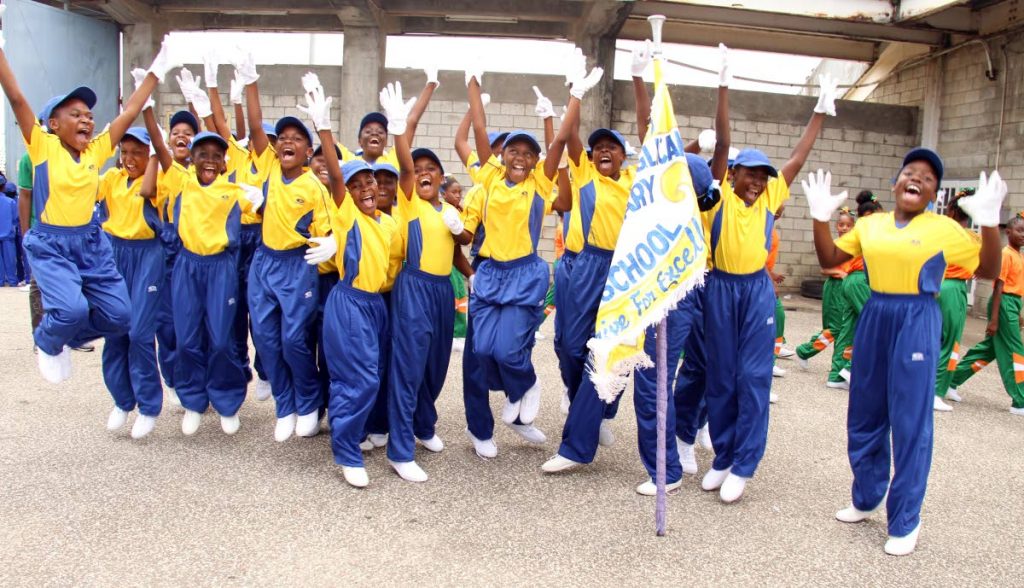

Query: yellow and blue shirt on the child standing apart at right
[836,212,981,295]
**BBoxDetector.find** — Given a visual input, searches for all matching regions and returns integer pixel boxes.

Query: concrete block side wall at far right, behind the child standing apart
[868,33,1024,316]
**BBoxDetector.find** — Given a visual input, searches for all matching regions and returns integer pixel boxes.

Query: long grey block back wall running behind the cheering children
[161,66,919,291]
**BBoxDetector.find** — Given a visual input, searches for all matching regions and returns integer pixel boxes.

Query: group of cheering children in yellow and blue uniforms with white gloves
[0,6,1024,553]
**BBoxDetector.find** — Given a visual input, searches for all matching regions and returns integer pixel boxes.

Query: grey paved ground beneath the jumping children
[0,289,1024,586]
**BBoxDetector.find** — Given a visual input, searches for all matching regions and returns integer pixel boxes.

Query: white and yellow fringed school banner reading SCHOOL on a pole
[587,59,707,403]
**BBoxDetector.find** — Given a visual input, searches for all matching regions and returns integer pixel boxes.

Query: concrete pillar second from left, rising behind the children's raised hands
[339,26,387,151]
